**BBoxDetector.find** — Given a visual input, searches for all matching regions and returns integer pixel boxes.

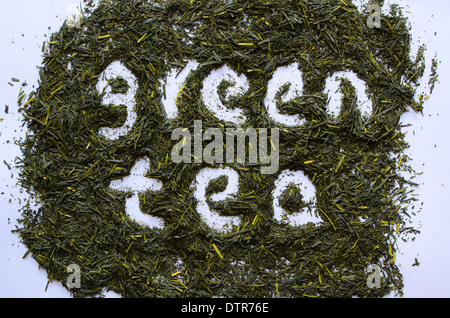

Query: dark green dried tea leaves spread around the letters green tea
[18,0,432,297]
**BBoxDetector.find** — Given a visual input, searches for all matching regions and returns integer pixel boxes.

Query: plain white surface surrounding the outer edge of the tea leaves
[0,0,450,298]
